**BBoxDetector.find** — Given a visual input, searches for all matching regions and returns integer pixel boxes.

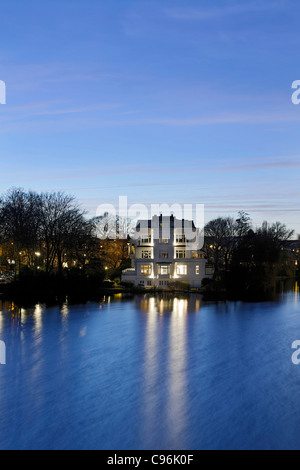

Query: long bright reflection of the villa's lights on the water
[138,295,196,447]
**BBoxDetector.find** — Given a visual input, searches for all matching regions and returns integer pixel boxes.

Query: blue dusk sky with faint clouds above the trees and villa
[0,0,300,233]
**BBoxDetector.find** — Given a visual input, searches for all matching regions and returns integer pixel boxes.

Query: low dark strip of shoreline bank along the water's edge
[0,276,299,306]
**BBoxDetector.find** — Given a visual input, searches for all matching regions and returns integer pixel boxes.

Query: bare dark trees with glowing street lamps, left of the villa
[0,189,128,302]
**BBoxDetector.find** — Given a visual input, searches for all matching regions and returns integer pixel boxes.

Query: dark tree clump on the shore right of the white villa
[205,212,300,300]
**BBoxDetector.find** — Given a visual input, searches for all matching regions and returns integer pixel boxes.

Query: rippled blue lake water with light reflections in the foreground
[0,289,300,450]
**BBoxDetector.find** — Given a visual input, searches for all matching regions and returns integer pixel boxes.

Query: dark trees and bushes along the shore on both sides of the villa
[0,189,300,302]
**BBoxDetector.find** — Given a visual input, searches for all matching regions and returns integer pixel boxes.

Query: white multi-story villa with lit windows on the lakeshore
[122,215,211,289]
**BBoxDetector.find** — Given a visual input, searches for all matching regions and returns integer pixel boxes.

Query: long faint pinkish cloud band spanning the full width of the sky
[0,103,300,134]
